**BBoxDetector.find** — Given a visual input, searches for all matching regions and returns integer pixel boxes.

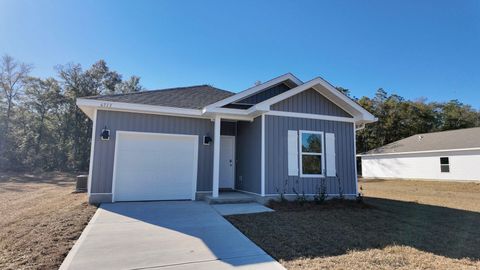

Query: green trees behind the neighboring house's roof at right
[355,88,480,153]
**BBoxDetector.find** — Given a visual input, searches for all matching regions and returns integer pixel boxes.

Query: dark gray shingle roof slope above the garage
[86,85,235,109]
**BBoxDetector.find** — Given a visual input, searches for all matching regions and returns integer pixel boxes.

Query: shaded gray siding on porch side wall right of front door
[235,117,262,194]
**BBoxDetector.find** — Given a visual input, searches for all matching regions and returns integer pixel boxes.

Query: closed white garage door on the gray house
[113,131,198,201]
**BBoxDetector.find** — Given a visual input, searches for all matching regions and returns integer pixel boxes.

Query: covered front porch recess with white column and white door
[209,116,262,200]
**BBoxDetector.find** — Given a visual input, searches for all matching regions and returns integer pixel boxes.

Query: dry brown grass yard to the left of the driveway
[0,173,96,269]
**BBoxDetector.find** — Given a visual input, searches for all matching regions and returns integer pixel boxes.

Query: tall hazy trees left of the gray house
[0,55,142,171]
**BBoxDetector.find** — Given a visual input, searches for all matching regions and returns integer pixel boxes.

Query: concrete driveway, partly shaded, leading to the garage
[60,202,284,270]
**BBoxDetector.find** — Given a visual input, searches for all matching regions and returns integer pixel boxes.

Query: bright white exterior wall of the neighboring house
[362,150,480,181]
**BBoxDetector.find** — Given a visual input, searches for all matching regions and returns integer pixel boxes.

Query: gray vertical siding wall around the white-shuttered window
[265,115,357,194]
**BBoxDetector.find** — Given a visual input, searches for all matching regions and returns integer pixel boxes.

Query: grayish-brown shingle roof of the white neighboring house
[362,127,480,156]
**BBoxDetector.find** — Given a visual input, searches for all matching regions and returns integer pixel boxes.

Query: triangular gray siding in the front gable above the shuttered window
[271,89,352,117]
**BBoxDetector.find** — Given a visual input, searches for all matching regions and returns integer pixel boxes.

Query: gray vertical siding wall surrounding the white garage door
[91,110,214,193]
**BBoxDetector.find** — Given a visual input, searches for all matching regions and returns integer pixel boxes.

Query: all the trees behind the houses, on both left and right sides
[0,55,480,171]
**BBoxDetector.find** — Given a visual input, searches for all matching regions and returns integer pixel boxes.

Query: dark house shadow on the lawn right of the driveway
[228,198,480,260]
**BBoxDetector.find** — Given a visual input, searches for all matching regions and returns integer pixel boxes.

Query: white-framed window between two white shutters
[299,131,324,177]
